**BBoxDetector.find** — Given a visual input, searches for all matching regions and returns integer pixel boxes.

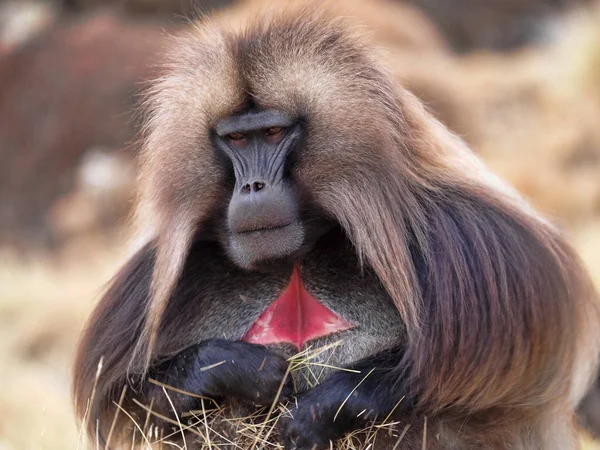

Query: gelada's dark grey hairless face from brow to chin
[213,109,327,269]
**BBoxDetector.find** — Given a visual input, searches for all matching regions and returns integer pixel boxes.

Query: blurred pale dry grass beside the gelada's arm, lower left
[0,234,127,450]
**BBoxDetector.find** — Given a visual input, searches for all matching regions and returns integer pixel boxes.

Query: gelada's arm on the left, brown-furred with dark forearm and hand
[74,244,292,438]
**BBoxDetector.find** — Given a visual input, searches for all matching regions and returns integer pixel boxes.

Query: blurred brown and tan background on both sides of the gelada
[0,0,600,450]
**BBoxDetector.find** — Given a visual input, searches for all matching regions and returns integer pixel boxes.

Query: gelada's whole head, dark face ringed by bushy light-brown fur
[142,14,399,270]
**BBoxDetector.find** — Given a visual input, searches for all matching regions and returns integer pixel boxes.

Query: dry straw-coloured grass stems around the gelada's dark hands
[78,341,414,450]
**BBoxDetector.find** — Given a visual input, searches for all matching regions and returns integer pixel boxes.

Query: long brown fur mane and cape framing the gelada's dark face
[75,3,600,450]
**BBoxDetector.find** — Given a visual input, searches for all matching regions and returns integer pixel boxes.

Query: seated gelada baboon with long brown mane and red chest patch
[75,2,599,450]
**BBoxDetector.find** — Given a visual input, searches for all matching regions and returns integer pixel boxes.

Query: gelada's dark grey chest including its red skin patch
[157,232,404,381]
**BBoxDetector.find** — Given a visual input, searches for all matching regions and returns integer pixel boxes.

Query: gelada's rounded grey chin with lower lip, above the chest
[228,223,306,270]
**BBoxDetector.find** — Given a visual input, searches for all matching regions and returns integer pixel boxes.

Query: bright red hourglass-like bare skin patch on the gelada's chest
[243,267,352,349]
